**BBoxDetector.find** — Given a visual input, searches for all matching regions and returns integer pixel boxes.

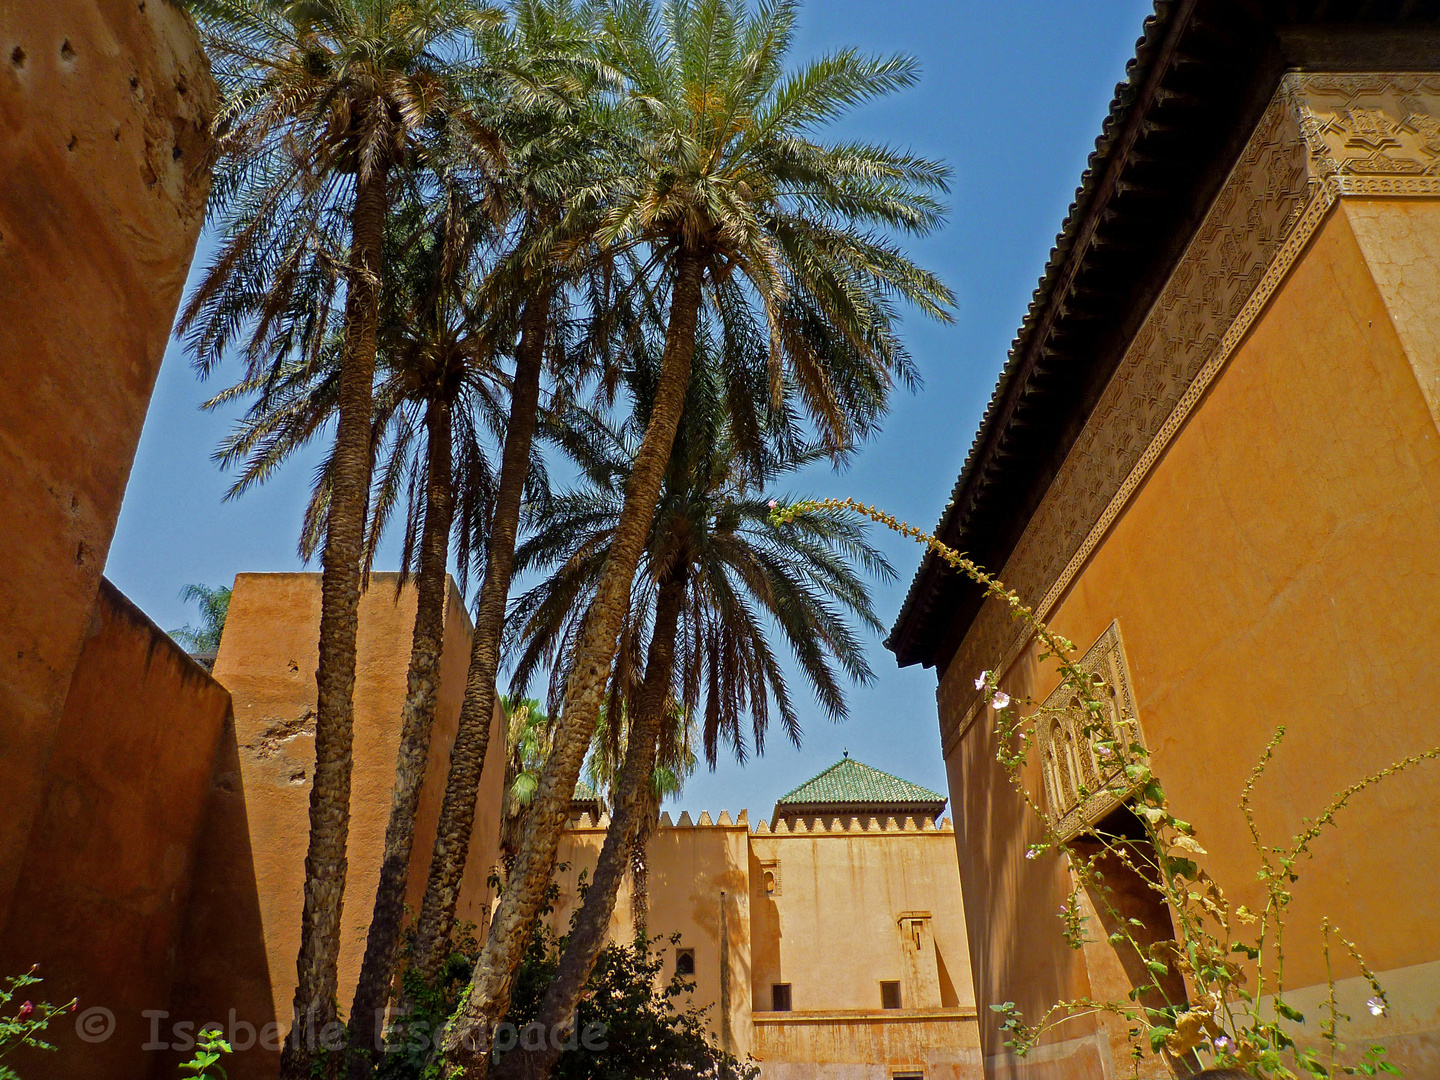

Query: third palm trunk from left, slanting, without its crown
[412,285,552,981]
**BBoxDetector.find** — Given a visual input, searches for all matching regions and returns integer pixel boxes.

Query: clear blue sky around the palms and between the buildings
[105,0,1152,818]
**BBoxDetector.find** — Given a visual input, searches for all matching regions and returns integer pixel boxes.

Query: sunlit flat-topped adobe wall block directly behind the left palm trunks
[174,573,504,1080]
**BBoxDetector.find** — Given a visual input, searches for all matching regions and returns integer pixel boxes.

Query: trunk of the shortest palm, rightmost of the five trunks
[495,567,685,1080]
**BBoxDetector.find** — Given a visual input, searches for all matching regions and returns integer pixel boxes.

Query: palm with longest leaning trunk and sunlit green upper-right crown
[442,0,952,1074]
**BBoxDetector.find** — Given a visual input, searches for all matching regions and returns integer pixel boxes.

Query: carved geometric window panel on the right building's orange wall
[1037,622,1145,841]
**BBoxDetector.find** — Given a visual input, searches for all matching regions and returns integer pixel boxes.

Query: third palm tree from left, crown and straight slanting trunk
[410,0,636,981]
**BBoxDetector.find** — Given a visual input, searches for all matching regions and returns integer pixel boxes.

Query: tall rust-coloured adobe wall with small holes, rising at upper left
[0,0,216,922]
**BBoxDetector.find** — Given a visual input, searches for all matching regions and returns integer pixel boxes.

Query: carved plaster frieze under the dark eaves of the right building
[939,73,1440,757]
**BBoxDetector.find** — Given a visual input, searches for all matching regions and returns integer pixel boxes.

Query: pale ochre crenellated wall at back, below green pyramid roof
[553,814,981,1080]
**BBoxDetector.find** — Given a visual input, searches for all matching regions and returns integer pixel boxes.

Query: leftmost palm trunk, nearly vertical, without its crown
[281,160,387,1080]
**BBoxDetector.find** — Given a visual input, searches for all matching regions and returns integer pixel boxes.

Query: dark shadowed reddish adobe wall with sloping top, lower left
[0,580,230,1080]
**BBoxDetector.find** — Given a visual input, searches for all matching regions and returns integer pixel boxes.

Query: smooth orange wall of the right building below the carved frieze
[940,200,1440,1077]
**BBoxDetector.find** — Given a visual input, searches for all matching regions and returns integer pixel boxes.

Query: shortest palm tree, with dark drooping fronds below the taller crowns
[486,357,894,1079]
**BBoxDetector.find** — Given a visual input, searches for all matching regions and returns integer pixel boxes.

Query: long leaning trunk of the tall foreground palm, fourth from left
[442,249,703,1079]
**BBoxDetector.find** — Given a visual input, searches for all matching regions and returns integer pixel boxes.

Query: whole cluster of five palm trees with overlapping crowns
[180,0,952,1080]
